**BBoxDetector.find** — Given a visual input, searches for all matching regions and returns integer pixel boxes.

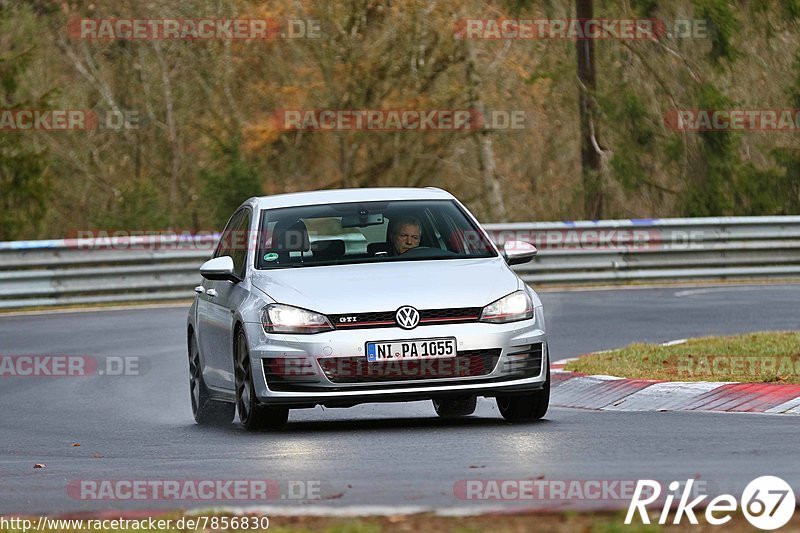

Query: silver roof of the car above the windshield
[246,187,454,209]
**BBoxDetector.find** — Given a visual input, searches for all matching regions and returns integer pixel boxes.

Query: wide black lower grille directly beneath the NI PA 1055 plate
[319,349,500,383]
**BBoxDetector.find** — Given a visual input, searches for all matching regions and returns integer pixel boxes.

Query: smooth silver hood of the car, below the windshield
[252,257,521,314]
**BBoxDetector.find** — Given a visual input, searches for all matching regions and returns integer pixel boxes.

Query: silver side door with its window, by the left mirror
[197,209,245,389]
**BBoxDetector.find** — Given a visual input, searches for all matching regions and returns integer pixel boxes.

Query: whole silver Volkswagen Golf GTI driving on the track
[187,188,550,429]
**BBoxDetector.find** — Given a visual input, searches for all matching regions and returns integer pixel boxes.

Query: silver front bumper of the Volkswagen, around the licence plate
[245,319,549,407]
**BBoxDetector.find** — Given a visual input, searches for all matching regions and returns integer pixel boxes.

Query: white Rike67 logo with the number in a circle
[625,476,795,530]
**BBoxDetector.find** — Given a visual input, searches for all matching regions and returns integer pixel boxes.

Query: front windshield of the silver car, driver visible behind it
[256,200,497,269]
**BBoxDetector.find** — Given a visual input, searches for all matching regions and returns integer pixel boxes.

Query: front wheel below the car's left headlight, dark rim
[234,331,289,431]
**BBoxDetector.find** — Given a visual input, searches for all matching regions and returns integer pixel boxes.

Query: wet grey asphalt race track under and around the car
[0,285,800,513]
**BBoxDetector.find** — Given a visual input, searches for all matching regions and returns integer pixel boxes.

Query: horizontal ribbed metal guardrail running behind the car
[0,216,800,309]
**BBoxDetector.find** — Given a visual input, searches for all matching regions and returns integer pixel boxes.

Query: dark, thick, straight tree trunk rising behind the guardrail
[576,0,603,220]
